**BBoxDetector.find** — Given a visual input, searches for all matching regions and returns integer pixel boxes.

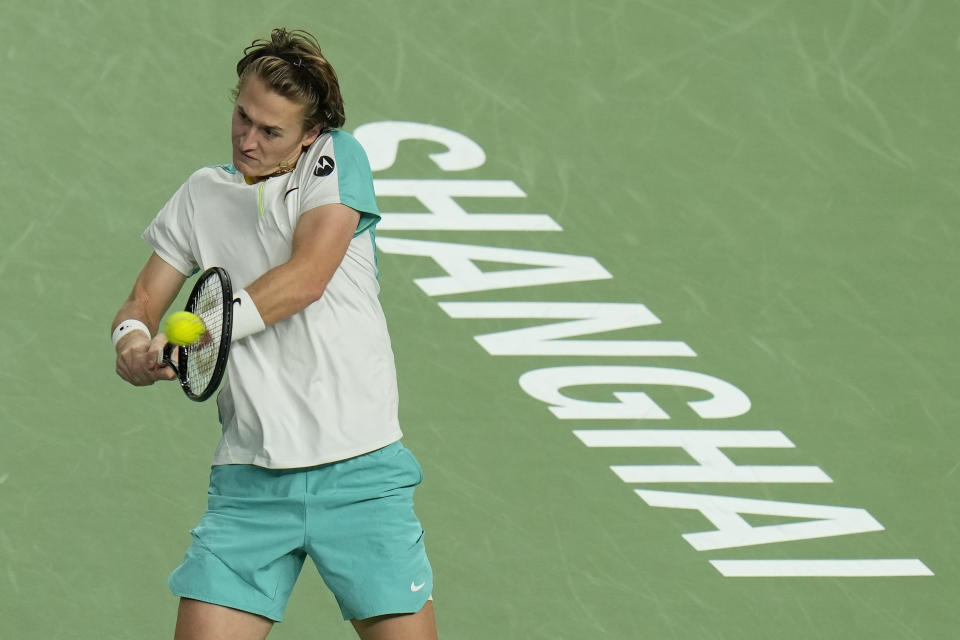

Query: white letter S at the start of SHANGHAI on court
[353,120,487,171]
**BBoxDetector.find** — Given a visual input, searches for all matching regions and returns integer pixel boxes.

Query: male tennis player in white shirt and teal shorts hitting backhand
[113,29,436,640]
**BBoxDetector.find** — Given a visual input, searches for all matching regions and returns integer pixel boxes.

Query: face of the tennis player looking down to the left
[231,76,318,178]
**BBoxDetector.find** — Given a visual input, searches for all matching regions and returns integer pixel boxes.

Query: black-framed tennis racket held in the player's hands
[162,267,233,402]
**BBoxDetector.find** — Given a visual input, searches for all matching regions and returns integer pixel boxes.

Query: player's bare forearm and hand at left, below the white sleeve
[113,253,187,387]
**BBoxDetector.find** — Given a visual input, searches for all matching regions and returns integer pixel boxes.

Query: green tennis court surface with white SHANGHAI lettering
[0,0,960,640]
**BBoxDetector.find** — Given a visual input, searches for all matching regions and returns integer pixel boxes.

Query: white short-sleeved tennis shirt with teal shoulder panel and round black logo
[143,131,402,469]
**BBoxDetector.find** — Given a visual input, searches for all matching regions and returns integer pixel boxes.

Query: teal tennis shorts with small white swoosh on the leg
[169,442,433,622]
